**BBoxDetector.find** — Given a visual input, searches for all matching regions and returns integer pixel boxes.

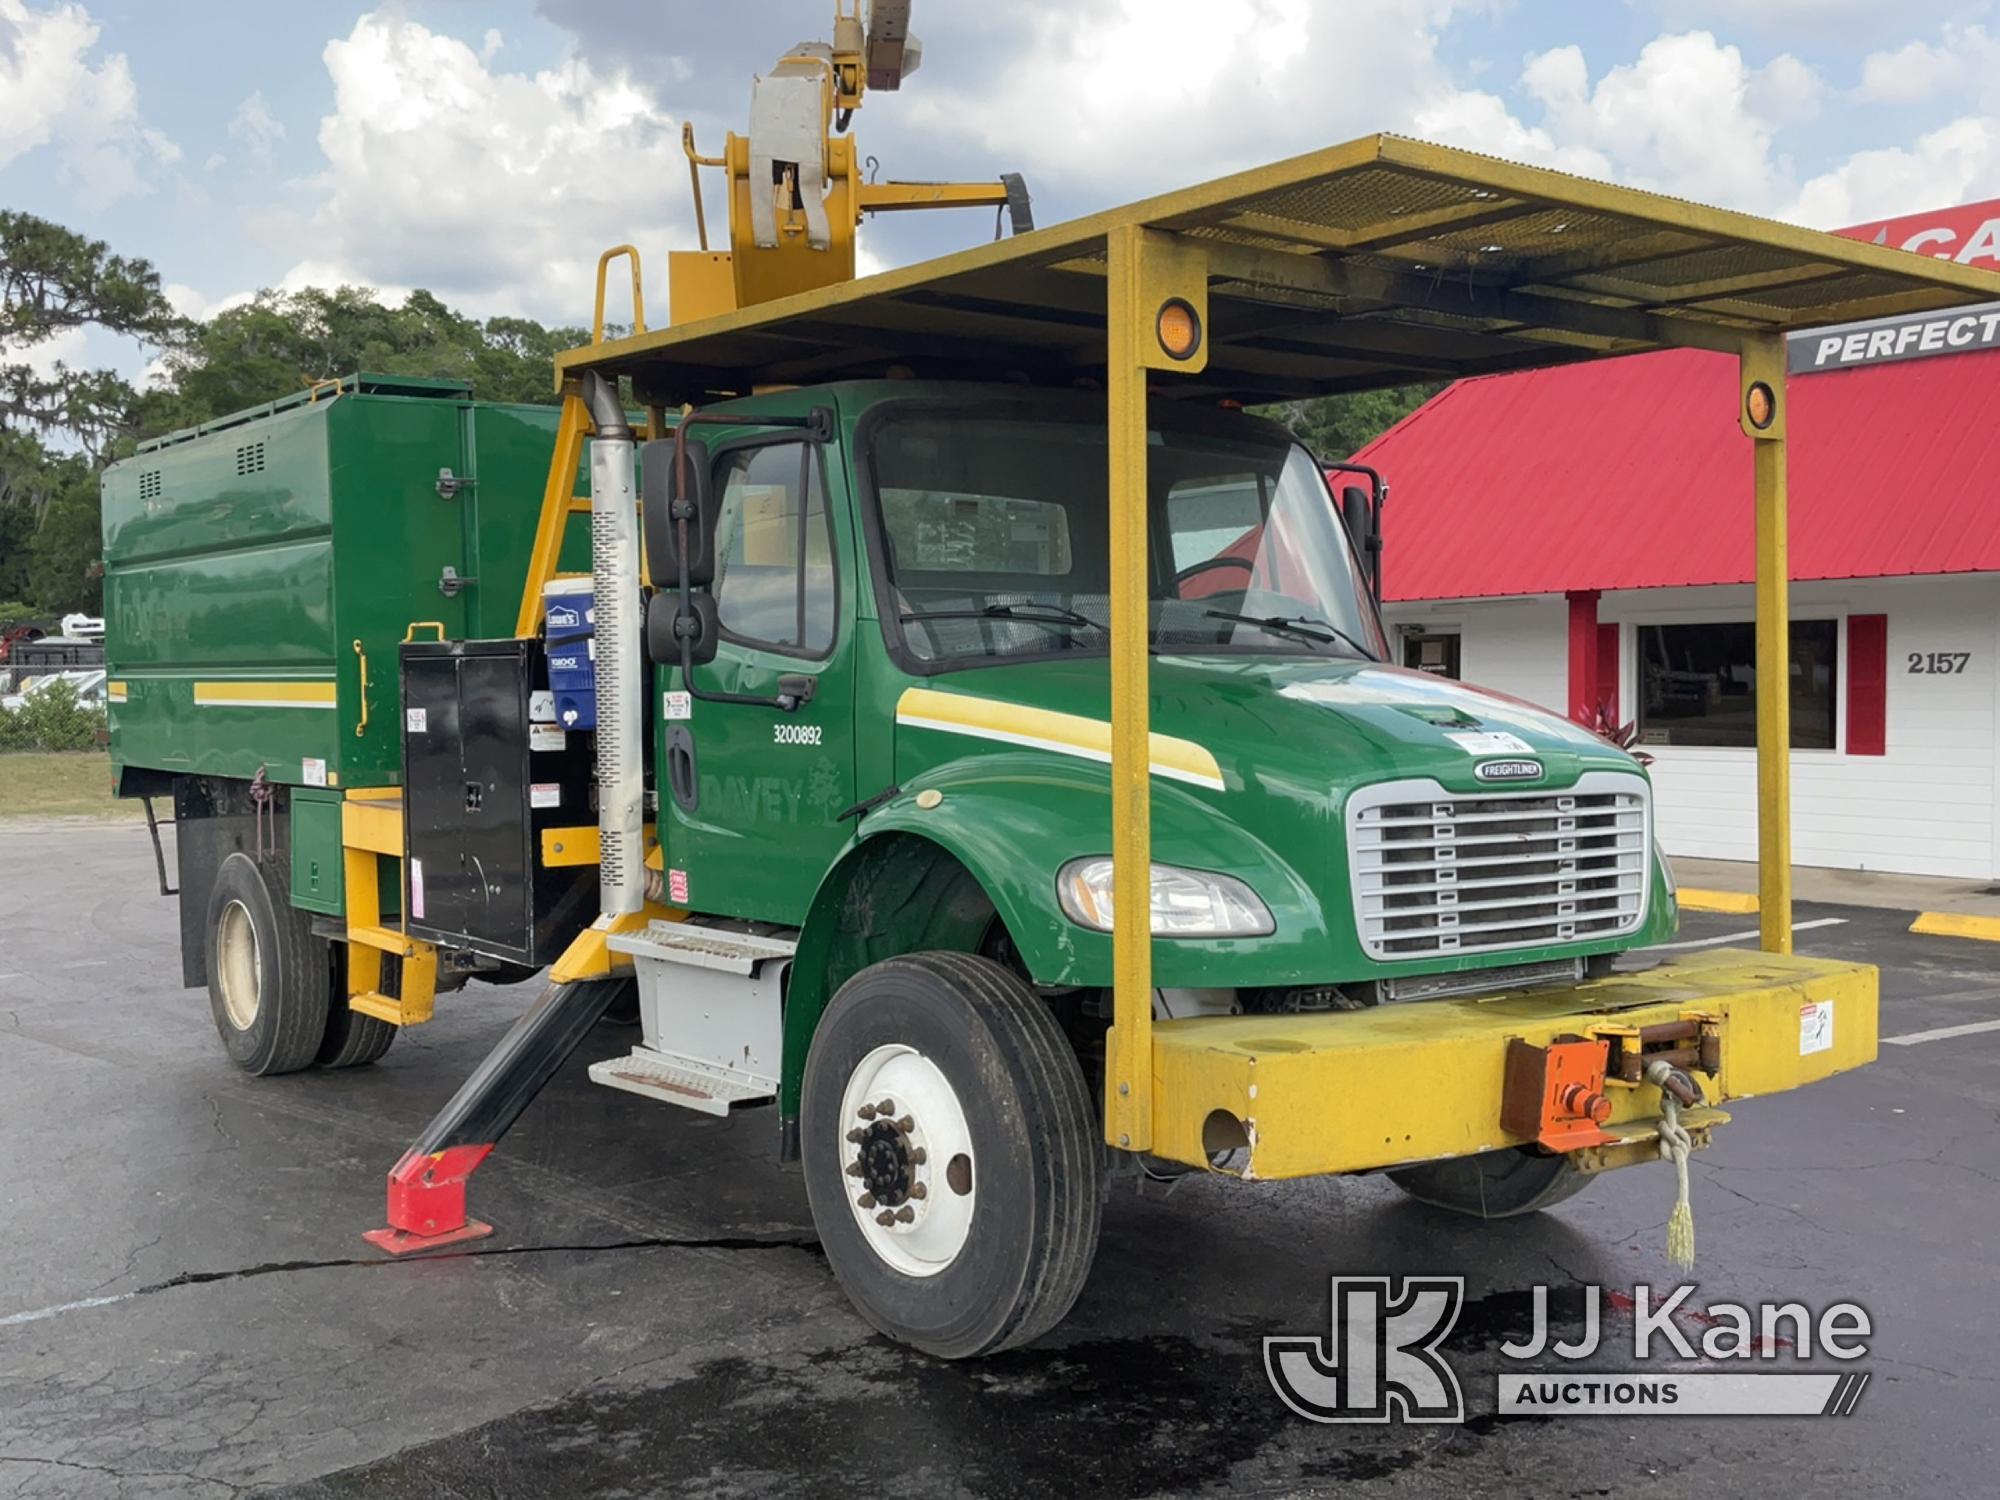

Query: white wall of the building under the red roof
[1388,574,2000,880]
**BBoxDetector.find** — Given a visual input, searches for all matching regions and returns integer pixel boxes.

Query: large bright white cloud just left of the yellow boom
[280,6,692,322]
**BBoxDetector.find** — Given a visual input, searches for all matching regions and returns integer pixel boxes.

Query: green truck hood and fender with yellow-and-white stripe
[870,656,1672,1000]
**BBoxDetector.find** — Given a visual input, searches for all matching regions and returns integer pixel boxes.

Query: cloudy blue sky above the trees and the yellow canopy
[0,0,2000,388]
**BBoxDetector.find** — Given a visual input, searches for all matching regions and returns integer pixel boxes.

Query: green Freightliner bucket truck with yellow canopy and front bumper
[104,4,2000,1356]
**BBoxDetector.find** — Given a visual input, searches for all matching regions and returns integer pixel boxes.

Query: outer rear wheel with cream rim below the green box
[204,852,332,1078]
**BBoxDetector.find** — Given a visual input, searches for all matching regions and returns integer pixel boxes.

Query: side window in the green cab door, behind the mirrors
[714,442,834,656]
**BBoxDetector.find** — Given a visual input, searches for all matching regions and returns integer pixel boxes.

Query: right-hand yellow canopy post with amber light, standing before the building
[1738,334,1792,954]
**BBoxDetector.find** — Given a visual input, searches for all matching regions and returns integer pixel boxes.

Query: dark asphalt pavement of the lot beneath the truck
[0,824,2000,1500]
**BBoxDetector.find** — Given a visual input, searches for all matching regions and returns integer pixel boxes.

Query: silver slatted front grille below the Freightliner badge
[1348,772,1652,960]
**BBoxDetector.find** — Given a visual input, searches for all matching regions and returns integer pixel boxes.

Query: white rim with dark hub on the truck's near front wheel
[838,1044,980,1276]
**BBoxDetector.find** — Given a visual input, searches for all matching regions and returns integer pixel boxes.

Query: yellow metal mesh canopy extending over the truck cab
[556,136,2000,404]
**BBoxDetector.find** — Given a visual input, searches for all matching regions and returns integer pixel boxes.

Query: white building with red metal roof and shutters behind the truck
[1356,202,2000,878]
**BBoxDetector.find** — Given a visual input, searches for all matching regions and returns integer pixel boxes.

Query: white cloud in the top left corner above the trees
[0,0,180,208]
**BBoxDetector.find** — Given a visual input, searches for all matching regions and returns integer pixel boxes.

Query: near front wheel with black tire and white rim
[800,954,1104,1360]
